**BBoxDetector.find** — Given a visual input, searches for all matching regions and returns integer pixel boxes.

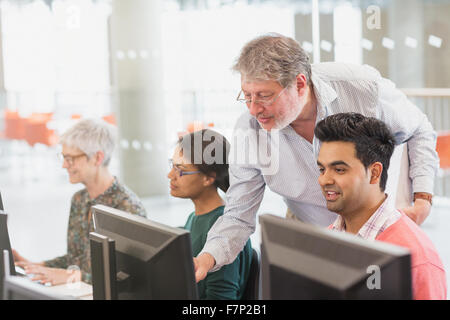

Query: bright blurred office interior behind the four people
[0,0,450,298]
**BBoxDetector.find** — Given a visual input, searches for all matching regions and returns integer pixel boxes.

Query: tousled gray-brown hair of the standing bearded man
[233,33,311,87]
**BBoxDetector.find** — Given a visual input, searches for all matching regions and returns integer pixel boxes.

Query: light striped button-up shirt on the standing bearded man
[200,62,439,271]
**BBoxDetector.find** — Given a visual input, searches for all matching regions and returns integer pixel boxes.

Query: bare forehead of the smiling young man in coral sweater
[318,141,359,165]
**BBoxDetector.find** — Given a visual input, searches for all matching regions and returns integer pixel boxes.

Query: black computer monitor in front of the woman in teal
[90,205,198,300]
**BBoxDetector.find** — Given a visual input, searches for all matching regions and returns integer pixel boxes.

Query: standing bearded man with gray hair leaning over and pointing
[194,34,438,281]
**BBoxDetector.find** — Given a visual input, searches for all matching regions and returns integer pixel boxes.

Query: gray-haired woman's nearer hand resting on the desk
[25,264,81,286]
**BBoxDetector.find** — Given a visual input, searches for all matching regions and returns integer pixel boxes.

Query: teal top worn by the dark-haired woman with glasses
[184,206,252,300]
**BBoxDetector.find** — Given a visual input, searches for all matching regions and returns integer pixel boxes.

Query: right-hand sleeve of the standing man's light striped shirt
[377,77,439,194]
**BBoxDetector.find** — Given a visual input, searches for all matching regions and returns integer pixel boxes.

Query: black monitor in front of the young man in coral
[259,214,412,300]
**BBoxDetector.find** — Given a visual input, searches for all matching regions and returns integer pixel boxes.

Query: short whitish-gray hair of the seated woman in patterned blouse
[59,119,117,167]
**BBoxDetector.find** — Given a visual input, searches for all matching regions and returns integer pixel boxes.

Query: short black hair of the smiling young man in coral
[314,112,395,191]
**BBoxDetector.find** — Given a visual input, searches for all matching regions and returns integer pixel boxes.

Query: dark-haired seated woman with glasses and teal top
[168,129,252,300]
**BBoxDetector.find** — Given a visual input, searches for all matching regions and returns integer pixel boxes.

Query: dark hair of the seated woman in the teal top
[178,129,230,192]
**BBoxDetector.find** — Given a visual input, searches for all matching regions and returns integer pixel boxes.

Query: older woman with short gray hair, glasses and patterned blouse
[14,119,146,285]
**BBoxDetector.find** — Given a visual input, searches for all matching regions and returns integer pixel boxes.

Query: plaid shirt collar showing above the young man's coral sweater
[331,197,402,240]
